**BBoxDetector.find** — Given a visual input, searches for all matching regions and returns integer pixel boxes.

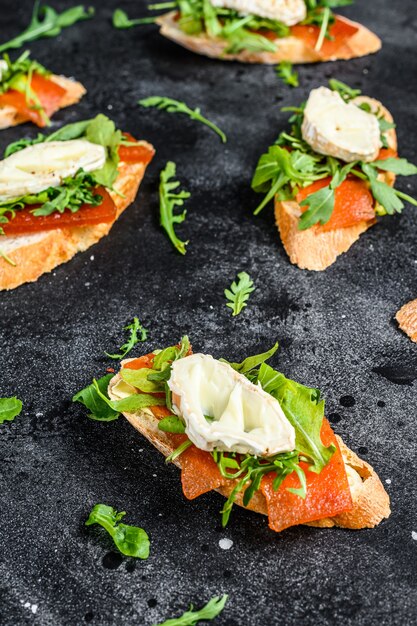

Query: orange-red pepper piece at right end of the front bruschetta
[261,419,353,532]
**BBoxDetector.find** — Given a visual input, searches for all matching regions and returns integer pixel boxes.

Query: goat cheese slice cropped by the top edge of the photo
[211,0,307,26]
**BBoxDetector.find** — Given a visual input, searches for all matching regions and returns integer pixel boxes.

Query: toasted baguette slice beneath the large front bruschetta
[108,366,391,529]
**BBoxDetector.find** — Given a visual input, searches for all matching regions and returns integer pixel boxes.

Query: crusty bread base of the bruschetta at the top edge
[156,11,381,65]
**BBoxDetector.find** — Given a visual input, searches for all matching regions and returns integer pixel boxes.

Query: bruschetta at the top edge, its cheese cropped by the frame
[142,0,381,64]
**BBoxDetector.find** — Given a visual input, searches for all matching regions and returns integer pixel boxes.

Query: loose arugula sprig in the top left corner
[0,0,94,52]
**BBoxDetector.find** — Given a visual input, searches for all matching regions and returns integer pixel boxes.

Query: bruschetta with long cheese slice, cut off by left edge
[0,114,154,290]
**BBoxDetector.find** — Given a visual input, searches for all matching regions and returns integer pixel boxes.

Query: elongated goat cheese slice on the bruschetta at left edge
[0,139,106,202]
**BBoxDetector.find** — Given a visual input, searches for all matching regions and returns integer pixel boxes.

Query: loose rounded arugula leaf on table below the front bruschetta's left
[85,504,150,559]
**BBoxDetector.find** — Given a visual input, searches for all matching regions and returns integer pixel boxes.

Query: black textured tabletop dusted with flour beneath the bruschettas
[0,0,417,626]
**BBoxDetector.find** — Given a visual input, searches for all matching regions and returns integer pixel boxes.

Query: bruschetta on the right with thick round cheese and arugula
[252,80,417,271]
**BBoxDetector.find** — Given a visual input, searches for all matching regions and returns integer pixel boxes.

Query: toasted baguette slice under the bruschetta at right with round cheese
[275,96,397,272]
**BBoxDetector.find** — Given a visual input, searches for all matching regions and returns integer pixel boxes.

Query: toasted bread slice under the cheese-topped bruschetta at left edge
[0,142,153,291]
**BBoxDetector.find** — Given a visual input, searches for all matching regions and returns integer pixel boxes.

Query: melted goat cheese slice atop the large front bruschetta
[168,354,295,456]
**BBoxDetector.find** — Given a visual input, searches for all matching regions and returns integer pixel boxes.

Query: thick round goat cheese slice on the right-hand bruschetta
[301,87,382,163]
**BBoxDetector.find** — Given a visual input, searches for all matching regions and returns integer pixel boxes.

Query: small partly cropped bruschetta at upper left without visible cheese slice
[0,51,86,129]
